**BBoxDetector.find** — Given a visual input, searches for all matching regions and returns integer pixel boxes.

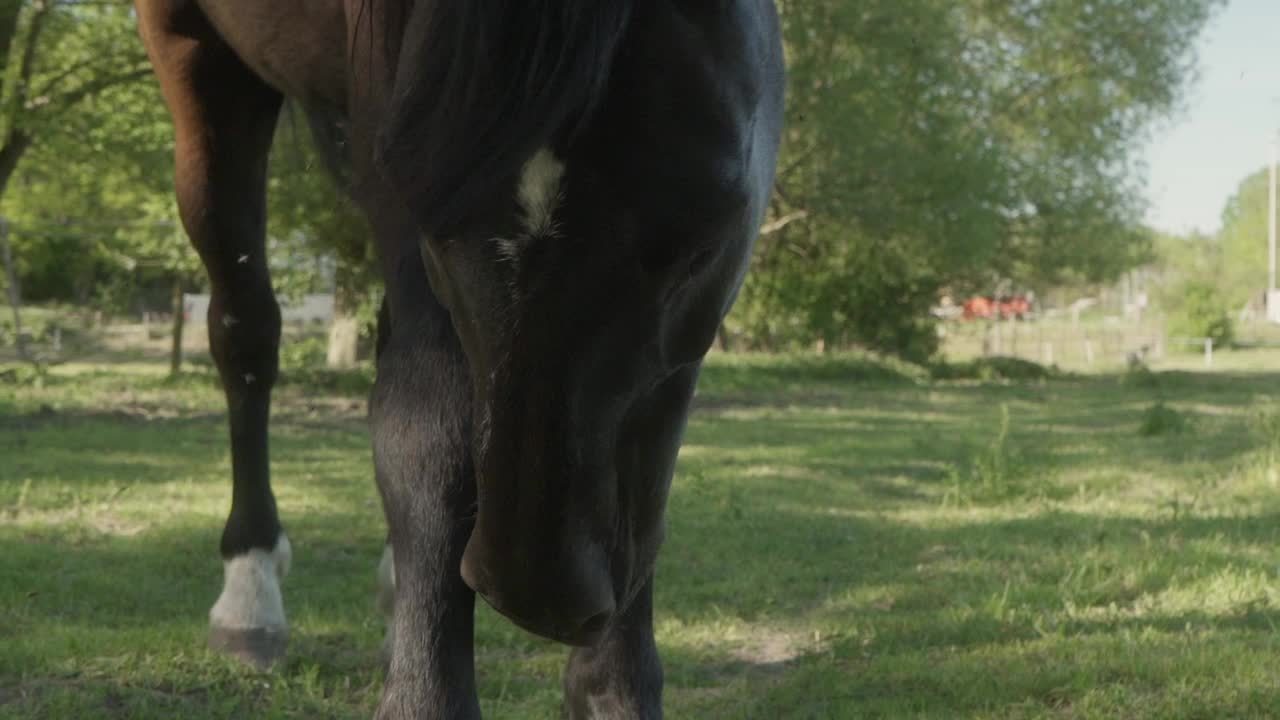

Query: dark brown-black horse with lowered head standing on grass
[136,0,783,719]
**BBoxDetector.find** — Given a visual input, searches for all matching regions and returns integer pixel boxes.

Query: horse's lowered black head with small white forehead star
[373,0,781,644]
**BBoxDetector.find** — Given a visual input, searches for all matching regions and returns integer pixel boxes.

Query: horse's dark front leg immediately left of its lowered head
[370,271,480,720]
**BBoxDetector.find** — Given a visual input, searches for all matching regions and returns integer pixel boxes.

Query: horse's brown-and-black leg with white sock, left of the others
[140,3,291,666]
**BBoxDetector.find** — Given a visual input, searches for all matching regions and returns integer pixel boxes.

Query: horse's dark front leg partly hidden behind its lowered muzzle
[562,578,662,720]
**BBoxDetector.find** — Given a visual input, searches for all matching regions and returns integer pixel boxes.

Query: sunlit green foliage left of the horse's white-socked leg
[0,1,177,309]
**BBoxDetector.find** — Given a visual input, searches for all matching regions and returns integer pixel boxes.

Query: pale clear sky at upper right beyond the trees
[1143,0,1280,232]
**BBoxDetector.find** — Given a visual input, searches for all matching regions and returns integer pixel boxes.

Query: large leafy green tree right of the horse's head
[727,0,1221,360]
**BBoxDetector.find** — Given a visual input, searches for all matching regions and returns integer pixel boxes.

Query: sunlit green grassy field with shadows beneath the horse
[0,354,1280,720]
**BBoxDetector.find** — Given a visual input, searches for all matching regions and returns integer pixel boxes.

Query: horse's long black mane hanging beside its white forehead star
[375,0,635,237]
